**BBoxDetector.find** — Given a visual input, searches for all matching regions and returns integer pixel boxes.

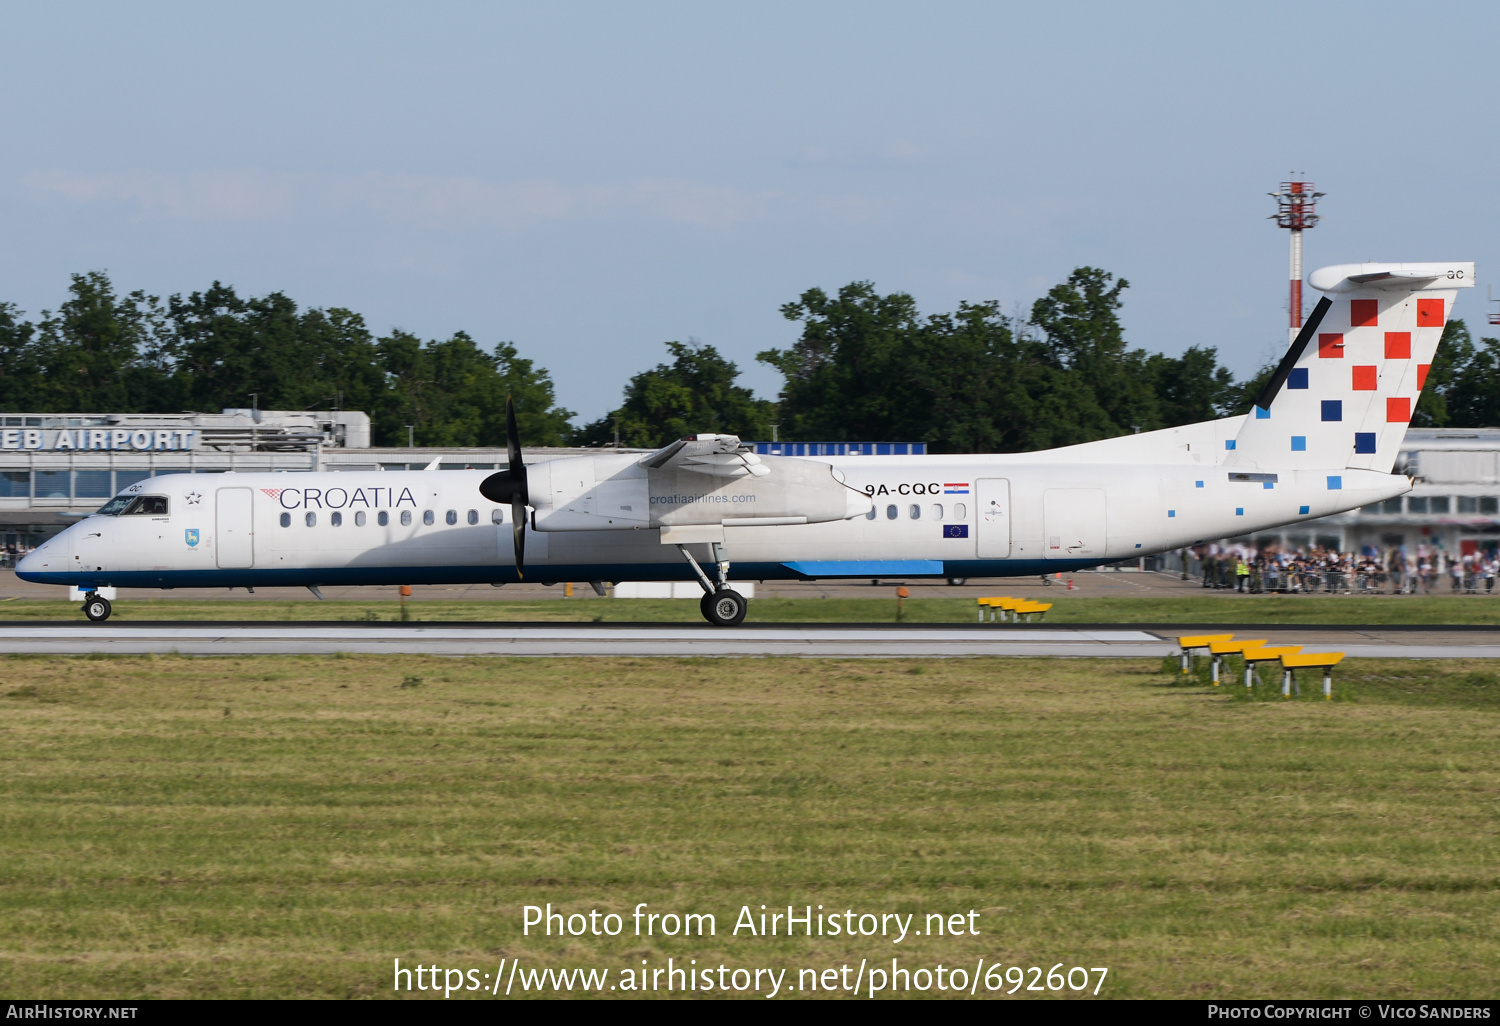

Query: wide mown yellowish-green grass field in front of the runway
[0,654,1500,999]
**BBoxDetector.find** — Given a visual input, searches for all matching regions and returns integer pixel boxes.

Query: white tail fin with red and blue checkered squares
[1224,263,1475,474]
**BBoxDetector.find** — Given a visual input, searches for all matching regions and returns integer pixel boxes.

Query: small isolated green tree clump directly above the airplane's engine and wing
[575,342,776,449]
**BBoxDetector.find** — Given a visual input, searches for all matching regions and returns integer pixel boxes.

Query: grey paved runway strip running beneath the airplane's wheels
[0,621,1500,659]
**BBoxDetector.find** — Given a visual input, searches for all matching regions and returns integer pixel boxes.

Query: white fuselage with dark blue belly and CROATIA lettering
[18,456,1410,590]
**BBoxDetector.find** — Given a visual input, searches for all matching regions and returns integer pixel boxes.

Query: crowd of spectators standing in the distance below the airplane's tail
[1188,545,1500,596]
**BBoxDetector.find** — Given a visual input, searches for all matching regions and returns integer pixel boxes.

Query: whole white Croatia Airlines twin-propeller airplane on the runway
[18,263,1475,626]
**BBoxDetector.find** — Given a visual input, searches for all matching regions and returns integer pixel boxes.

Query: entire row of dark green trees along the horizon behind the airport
[0,267,1500,453]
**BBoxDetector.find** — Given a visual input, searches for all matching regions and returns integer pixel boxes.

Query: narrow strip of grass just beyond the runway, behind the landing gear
[0,587,1500,630]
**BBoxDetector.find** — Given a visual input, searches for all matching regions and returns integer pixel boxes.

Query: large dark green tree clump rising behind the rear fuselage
[759,267,1233,452]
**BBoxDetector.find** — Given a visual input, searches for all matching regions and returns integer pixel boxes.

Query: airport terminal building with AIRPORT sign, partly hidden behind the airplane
[0,410,1500,554]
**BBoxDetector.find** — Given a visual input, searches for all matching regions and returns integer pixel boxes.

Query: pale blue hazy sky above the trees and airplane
[0,2,1500,419]
